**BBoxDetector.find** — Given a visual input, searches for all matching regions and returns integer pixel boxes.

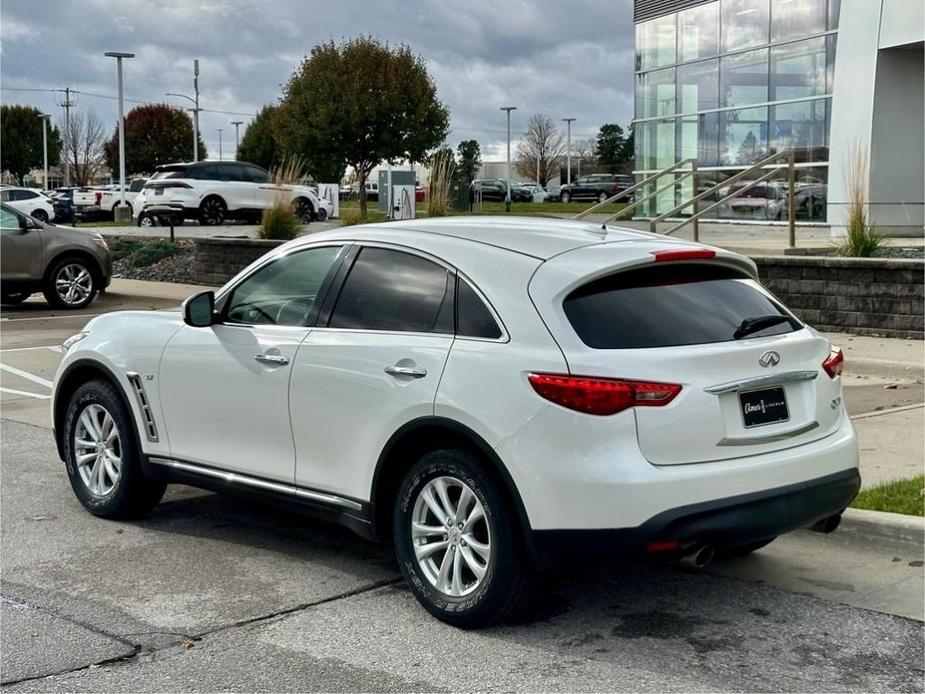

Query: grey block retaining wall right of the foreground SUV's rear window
[753,256,925,340]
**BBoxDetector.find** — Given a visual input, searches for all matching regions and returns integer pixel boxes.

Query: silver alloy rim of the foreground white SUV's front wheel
[74,404,122,496]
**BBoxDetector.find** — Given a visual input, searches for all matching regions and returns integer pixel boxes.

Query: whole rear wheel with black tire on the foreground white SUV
[393,449,532,628]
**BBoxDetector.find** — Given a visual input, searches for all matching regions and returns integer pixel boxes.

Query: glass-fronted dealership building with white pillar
[634,0,925,235]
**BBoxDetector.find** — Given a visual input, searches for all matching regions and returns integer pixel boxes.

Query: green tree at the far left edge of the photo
[0,104,61,184]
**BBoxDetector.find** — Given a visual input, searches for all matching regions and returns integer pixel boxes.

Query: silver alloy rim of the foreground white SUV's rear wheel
[410,476,491,597]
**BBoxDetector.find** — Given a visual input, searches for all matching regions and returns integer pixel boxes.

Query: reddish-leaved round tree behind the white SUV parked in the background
[103,104,206,174]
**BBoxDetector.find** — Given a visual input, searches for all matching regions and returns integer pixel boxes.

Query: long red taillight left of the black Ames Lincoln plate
[528,374,681,415]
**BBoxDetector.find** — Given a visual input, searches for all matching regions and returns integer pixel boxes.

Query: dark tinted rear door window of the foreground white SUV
[330,248,453,333]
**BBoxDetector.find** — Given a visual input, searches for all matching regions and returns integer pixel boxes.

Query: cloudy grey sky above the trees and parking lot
[0,0,633,159]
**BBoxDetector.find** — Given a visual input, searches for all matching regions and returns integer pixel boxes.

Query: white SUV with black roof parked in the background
[132,161,333,226]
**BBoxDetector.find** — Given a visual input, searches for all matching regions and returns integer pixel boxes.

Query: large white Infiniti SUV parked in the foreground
[52,217,860,626]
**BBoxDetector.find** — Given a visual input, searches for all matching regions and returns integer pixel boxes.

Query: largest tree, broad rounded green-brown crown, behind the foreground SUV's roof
[276,37,449,212]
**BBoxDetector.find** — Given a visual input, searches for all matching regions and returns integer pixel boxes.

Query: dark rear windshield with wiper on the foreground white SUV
[563,263,802,349]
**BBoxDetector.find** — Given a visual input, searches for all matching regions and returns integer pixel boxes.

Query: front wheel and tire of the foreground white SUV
[62,381,167,519]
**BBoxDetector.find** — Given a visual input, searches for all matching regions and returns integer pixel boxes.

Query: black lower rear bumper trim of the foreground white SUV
[533,468,861,568]
